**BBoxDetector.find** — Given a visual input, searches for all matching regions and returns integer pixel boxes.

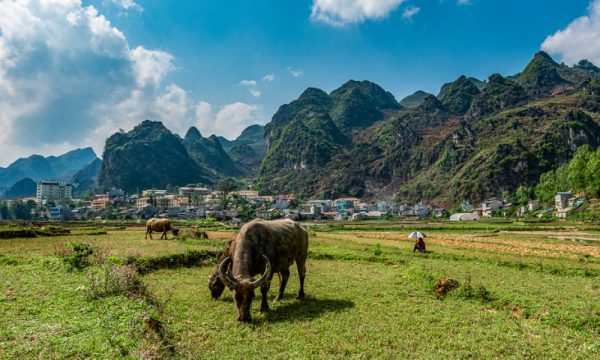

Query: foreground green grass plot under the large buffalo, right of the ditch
[146,259,600,359]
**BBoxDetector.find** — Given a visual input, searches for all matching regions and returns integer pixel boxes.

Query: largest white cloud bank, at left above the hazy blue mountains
[0,0,178,165]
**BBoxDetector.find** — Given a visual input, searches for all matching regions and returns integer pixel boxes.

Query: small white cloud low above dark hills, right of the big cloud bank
[196,101,265,139]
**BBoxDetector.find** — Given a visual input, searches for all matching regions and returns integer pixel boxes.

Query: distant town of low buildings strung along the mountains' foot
[0,180,587,224]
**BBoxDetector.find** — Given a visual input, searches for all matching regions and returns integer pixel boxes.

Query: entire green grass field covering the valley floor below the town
[0,222,600,359]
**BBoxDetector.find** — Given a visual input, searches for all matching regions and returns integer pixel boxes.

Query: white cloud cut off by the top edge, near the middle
[311,0,405,26]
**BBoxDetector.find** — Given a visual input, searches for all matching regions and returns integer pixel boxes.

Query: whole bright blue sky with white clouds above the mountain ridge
[0,0,600,166]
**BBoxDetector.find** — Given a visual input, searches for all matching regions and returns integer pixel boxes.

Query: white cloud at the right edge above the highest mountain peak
[542,0,600,64]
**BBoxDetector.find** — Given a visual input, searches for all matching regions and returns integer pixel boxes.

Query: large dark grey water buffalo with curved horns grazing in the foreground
[218,219,308,322]
